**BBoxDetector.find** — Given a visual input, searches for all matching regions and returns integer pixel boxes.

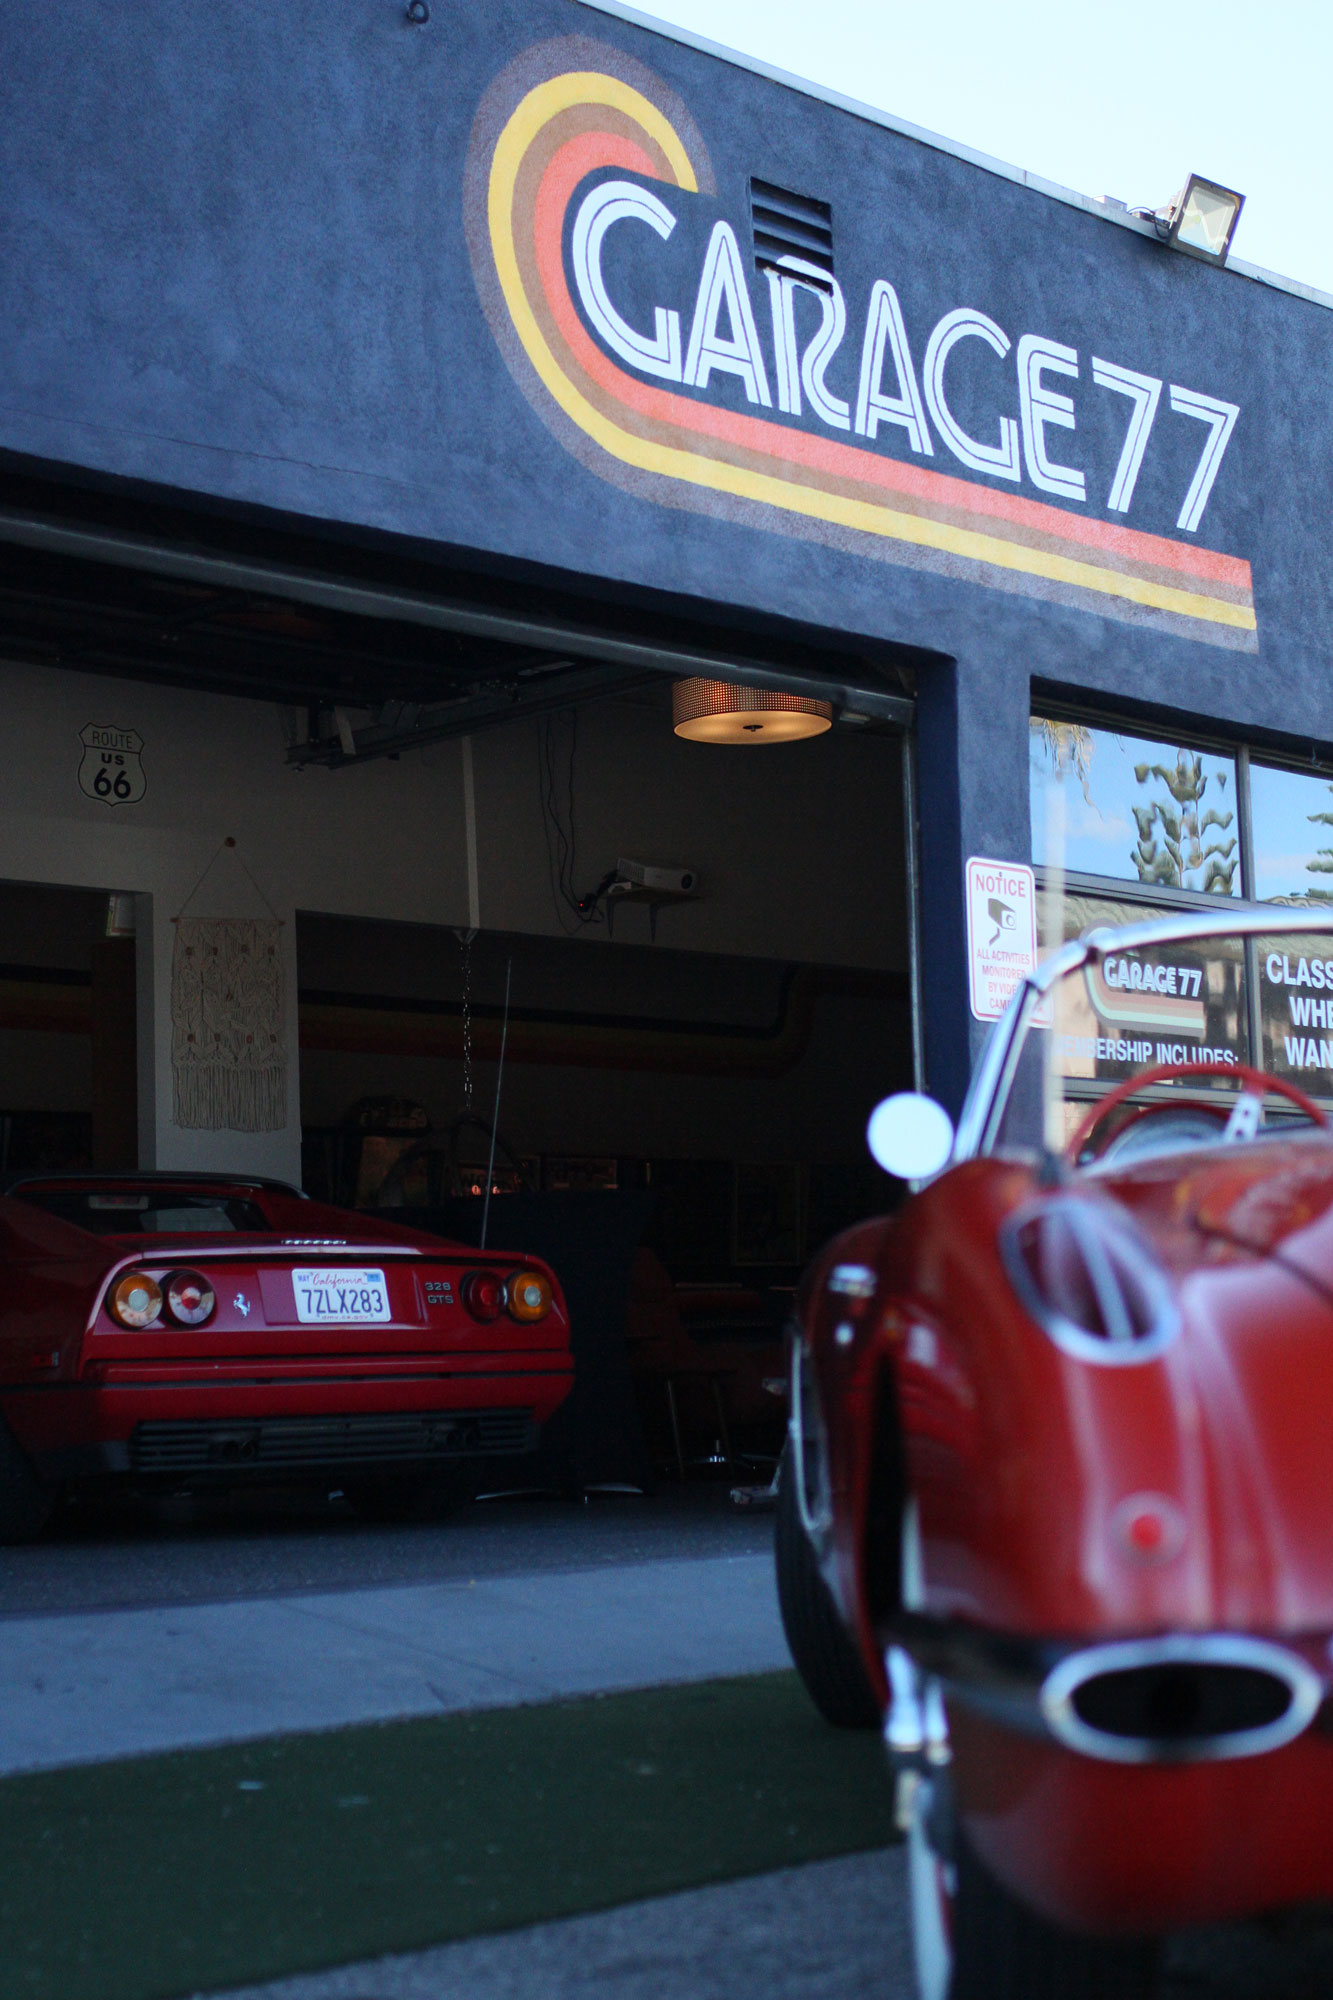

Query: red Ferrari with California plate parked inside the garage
[0,1174,572,1542]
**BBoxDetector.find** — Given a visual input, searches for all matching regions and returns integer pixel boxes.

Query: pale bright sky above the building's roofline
[616,0,1333,292]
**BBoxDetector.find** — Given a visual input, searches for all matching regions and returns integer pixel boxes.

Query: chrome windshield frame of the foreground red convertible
[953,904,1333,1164]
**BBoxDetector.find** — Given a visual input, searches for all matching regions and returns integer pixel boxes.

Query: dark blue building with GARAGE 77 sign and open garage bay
[0,0,1333,1284]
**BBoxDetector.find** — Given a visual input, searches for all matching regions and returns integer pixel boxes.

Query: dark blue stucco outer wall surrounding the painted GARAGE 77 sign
[0,0,1333,1096]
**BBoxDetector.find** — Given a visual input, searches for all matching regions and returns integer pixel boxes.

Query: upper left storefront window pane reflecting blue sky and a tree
[1029,716,1232,896]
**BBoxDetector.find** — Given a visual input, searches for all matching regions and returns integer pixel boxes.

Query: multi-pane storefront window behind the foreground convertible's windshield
[1009,716,1333,1136]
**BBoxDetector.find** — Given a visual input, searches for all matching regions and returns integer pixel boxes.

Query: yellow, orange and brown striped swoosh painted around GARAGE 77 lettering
[464,36,1257,652]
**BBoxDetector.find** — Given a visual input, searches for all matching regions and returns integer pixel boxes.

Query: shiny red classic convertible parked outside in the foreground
[779,898,1333,2000]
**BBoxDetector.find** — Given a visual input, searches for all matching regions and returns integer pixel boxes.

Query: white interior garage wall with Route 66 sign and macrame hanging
[0,664,907,1178]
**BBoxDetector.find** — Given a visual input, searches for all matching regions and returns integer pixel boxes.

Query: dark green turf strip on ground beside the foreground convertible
[0,1674,895,2000]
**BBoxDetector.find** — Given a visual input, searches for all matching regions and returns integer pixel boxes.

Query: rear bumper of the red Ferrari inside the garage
[0,1356,572,1480]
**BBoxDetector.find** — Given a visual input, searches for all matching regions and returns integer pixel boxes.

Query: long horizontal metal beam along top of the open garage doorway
[0,510,913,728]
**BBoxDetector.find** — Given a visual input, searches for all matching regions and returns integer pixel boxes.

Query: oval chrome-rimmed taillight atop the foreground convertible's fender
[1003,1196,1177,1362]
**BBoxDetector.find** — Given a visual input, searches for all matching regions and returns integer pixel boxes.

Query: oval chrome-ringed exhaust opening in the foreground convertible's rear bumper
[1041,1632,1323,1764]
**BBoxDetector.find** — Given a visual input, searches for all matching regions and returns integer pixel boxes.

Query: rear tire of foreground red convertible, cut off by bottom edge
[907,1780,1161,2000]
